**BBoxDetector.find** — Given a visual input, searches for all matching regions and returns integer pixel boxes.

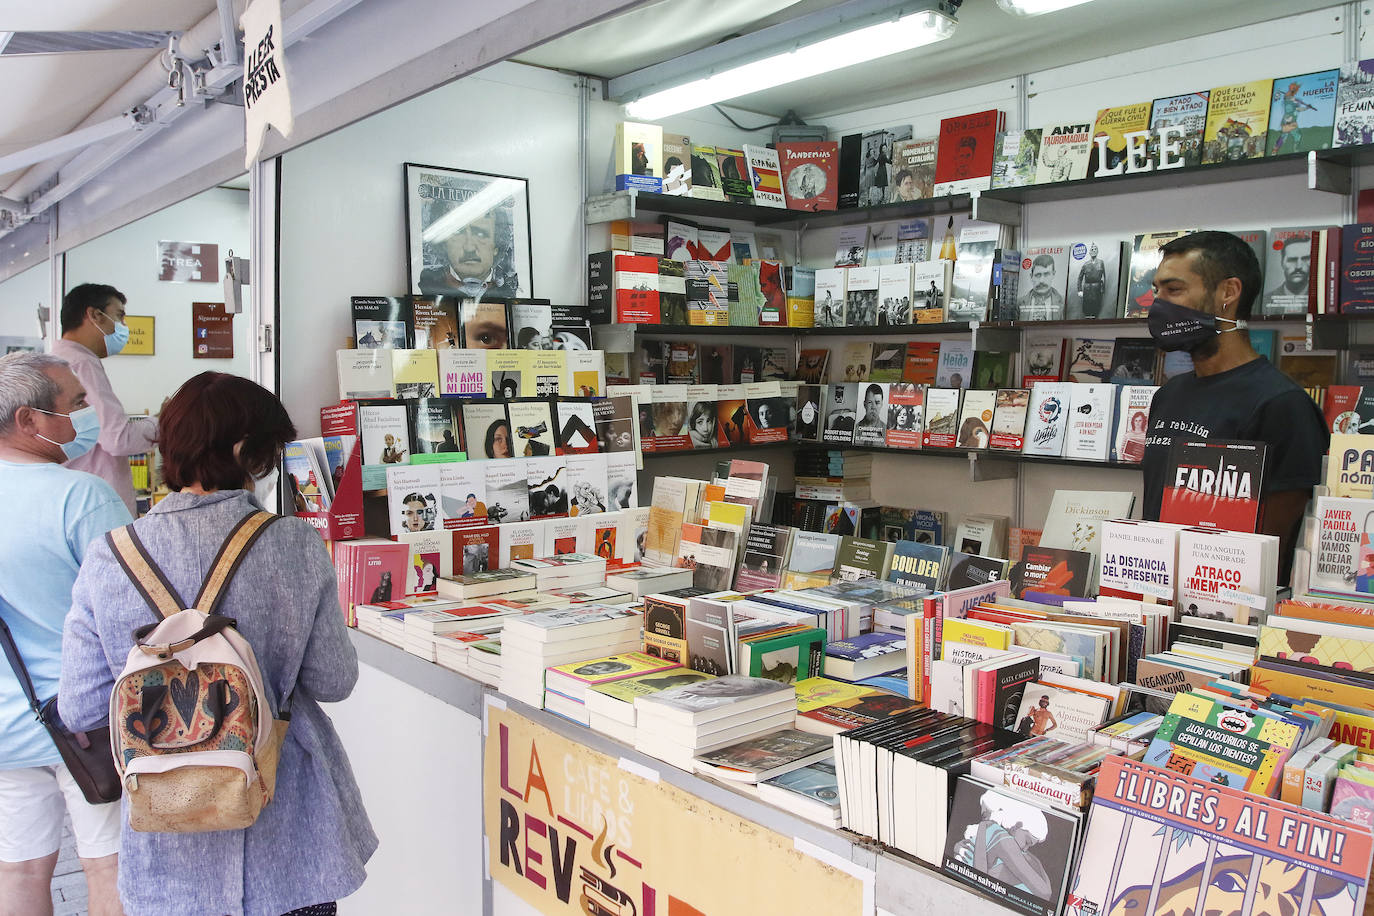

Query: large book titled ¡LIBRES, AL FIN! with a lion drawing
[1066,757,1371,916]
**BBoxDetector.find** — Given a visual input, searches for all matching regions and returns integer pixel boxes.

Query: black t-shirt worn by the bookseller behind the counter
[1140,356,1331,520]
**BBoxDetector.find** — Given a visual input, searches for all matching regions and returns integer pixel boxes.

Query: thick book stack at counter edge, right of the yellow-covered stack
[635,674,797,770]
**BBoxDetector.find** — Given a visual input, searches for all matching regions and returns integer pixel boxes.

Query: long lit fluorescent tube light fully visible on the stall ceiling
[625,10,956,121]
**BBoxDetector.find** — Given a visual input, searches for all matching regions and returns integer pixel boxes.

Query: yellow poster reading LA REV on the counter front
[482,705,872,916]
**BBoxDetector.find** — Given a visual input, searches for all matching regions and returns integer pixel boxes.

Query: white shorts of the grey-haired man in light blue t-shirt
[0,764,122,862]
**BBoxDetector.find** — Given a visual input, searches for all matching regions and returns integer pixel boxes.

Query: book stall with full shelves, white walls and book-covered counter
[13,0,1374,916]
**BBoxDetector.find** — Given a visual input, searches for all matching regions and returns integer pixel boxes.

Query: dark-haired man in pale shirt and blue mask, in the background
[52,283,158,515]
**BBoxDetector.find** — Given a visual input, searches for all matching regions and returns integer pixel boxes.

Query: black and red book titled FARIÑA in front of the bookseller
[1160,439,1268,531]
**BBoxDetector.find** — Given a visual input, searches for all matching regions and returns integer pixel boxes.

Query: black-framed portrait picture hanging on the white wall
[404,162,534,301]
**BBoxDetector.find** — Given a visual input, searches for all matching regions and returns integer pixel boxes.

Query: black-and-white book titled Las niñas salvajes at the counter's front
[940,776,1080,916]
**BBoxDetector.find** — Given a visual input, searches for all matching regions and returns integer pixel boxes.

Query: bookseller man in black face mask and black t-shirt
[1140,232,1330,584]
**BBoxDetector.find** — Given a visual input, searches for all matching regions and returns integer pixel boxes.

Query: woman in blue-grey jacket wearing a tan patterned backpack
[59,372,376,916]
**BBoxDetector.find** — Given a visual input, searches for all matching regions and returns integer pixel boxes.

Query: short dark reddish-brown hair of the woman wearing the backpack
[158,372,295,490]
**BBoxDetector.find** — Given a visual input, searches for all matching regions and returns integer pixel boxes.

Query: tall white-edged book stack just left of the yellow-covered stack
[500,604,642,707]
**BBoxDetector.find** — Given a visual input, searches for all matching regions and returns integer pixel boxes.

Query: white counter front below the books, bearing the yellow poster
[328,630,1010,916]
